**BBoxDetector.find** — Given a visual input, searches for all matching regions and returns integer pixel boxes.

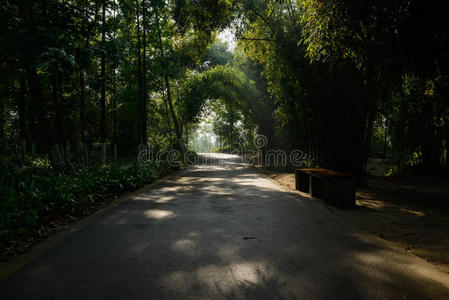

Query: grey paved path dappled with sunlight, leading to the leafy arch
[0,155,449,299]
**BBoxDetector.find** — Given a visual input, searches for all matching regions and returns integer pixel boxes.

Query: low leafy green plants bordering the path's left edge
[0,159,172,249]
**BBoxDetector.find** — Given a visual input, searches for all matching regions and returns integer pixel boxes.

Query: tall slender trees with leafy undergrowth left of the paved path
[0,0,234,249]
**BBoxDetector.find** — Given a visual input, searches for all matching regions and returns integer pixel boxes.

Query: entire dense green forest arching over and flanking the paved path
[0,0,449,253]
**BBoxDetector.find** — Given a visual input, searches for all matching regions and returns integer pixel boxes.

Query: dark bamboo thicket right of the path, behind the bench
[234,0,449,174]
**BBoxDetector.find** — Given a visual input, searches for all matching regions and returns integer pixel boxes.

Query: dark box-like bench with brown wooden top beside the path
[295,169,355,207]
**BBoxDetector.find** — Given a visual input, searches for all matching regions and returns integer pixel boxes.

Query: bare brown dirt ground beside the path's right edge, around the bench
[261,169,449,273]
